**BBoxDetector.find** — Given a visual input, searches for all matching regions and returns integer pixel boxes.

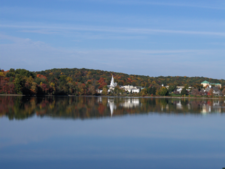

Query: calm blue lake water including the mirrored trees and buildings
[0,97,225,169]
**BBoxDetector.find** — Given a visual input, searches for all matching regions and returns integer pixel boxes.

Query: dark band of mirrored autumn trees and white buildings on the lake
[0,97,225,119]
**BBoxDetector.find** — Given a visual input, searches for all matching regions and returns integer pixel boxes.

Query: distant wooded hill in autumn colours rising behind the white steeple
[36,68,225,87]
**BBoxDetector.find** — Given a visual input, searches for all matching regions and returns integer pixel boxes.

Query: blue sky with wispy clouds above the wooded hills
[0,0,225,79]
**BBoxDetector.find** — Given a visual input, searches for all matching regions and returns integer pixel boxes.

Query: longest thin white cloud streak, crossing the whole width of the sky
[0,23,225,37]
